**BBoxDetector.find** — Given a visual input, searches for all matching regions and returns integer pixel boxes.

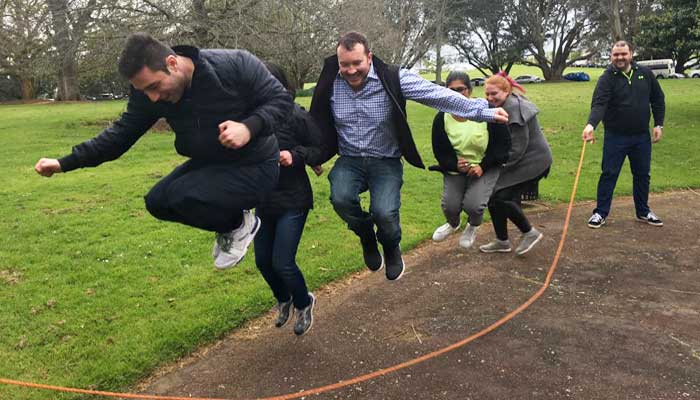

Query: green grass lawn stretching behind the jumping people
[0,76,700,399]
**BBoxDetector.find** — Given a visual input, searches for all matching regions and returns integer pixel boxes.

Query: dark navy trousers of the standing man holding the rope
[593,130,651,218]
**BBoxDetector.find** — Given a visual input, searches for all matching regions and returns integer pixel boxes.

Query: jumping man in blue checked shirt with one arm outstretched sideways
[311,32,508,280]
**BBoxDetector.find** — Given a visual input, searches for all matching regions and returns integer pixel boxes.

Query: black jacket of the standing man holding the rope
[588,63,666,134]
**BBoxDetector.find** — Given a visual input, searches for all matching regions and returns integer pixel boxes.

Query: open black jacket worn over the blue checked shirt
[309,56,425,168]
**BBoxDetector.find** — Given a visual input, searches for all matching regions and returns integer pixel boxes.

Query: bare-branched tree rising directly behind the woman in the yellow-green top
[449,0,526,76]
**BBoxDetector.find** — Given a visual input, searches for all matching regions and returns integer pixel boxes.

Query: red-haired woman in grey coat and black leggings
[479,72,552,255]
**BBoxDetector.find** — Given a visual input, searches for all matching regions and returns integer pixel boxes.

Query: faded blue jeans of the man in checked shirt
[328,156,403,249]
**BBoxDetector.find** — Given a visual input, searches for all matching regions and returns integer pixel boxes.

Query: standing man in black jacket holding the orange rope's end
[582,40,666,228]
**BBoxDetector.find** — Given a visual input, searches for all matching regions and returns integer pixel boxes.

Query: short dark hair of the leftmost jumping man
[119,32,175,79]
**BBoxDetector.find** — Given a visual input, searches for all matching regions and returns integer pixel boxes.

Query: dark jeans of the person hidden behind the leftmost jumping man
[254,209,311,309]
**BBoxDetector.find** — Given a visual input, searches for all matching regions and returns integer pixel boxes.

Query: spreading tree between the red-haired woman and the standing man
[516,0,595,80]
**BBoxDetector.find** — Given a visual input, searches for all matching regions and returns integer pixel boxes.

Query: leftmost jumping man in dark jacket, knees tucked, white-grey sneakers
[35,33,292,269]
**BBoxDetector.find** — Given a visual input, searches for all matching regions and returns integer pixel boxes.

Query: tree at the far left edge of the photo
[0,0,48,100]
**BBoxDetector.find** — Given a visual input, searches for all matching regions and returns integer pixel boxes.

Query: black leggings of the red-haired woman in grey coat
[489,178,539,240]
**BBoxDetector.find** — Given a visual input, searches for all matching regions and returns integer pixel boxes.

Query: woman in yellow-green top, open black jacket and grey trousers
[430,71,510,248]
